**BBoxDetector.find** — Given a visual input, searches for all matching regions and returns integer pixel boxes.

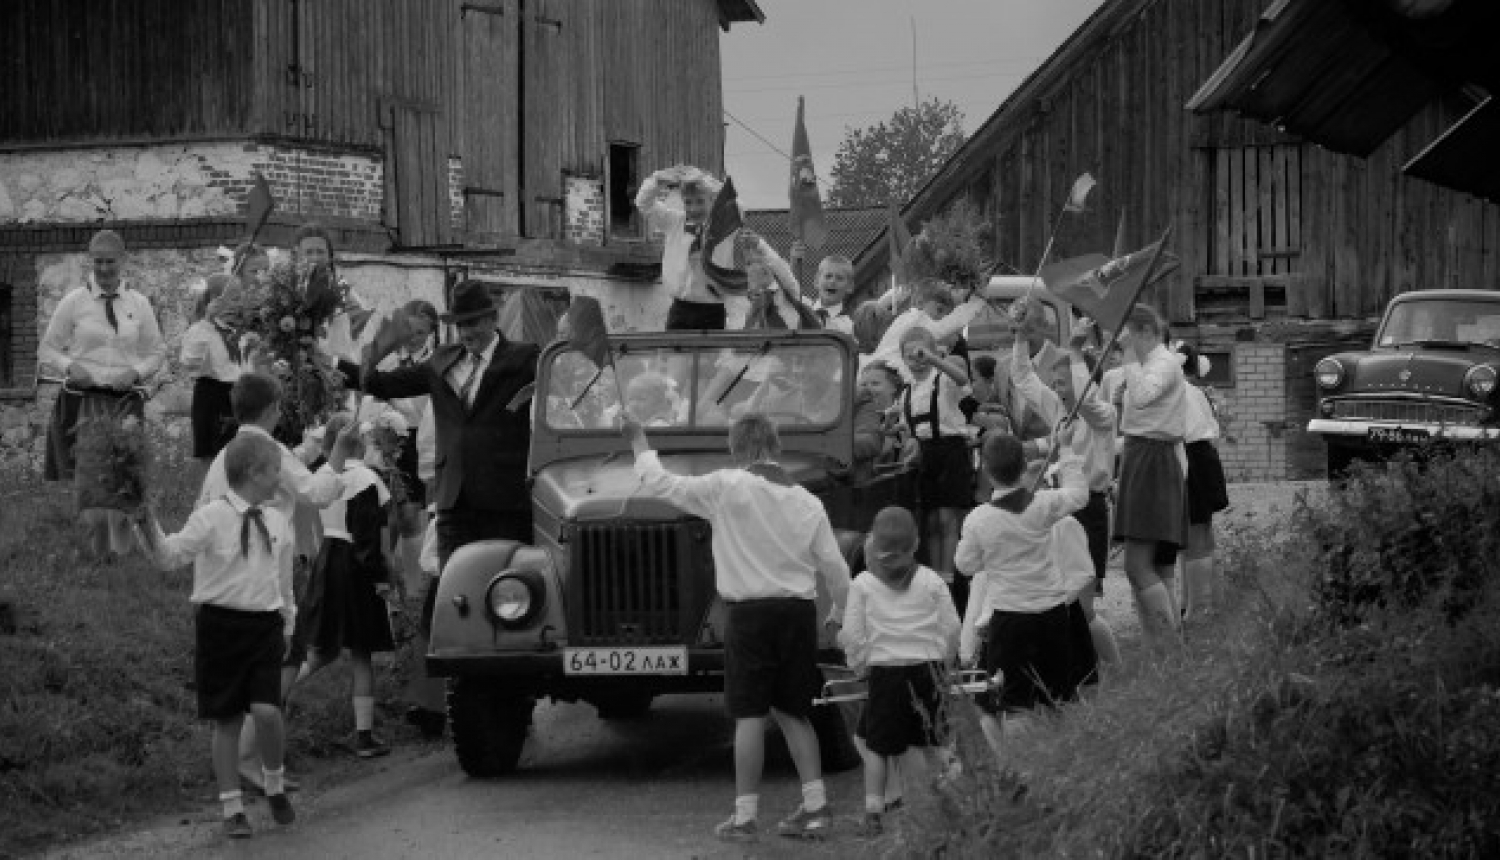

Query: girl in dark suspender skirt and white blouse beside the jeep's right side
[902,326,975,612]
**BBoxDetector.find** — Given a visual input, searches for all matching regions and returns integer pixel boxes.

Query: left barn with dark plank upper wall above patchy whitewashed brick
[0,0,764,429]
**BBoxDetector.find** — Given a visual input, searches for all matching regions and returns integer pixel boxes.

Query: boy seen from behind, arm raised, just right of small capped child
[954,434,1089,755]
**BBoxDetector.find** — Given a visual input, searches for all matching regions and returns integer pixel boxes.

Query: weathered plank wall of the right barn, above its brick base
[909,0,1500,321]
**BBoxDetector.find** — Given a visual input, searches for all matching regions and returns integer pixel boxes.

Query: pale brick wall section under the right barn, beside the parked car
[1218,342,1287,482]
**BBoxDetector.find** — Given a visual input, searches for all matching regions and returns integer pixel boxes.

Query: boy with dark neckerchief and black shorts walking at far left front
[138,435,297,839]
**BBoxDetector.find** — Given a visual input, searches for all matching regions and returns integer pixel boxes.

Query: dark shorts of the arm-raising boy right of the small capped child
[980,603,1092,714]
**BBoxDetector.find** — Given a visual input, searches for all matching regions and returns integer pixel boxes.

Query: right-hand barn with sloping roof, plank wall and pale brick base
[857,0,1500,480]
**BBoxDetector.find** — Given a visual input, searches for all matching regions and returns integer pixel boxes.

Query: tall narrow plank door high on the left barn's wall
[459,0,521,243]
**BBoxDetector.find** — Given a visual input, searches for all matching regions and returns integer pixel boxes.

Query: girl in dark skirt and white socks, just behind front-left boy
[288,414,395,758]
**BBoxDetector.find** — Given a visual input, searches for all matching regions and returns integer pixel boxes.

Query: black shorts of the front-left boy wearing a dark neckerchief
[194,603,287,720]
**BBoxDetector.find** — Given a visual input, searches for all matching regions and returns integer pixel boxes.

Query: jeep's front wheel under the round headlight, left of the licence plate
[449,678,537,777]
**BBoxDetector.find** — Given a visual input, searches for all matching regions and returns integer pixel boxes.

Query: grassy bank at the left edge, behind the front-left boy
[0,440,423,855]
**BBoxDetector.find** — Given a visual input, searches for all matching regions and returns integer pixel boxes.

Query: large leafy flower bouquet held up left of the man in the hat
[245,264,347,438]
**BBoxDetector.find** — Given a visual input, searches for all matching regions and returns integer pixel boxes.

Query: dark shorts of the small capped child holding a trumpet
[855,663,947,755]
